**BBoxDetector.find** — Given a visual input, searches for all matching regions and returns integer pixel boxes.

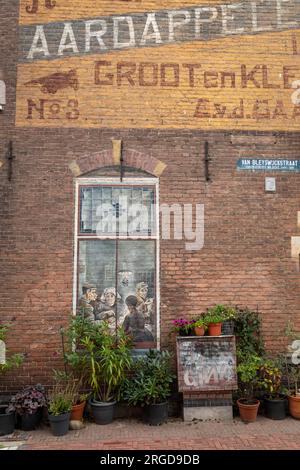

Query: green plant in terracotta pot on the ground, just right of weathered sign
[237,354,261,423]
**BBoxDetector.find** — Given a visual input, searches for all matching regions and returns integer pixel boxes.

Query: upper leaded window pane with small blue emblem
[80,186,156,237]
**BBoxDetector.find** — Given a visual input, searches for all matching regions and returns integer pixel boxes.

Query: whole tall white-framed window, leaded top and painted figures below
[74,178,159,349]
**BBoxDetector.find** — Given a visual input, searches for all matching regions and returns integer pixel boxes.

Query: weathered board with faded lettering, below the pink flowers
[177,336,237,392]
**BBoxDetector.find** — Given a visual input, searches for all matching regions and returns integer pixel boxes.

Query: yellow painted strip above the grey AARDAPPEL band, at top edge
[20,0,236,25]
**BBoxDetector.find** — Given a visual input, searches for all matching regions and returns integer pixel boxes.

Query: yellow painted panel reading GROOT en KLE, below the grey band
[16,34,300,131]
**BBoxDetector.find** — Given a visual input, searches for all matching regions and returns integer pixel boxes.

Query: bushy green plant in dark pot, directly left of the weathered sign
[123,350,175,425]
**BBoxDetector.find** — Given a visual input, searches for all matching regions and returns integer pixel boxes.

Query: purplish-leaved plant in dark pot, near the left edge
[8,384,47,431]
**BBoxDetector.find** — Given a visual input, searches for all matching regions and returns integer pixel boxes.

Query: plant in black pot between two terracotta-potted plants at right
[259,359,286,420]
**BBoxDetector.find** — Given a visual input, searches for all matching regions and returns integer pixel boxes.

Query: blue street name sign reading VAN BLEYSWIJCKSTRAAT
[237,158,300,172]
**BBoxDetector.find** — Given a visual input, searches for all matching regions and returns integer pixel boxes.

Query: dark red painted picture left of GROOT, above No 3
[26,69,79,95]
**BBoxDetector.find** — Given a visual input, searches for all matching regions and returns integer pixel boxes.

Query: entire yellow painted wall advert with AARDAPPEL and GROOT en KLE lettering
[16,0,300,130]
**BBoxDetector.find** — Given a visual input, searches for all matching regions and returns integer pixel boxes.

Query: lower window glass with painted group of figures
[77,240,156,349]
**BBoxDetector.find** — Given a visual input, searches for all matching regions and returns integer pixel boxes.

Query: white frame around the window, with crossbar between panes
[73,177,161,350]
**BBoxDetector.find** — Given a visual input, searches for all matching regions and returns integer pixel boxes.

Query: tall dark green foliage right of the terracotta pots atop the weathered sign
[234,308,265,362]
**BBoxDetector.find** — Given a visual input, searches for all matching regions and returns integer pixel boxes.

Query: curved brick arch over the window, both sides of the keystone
[69,150,167,177]
